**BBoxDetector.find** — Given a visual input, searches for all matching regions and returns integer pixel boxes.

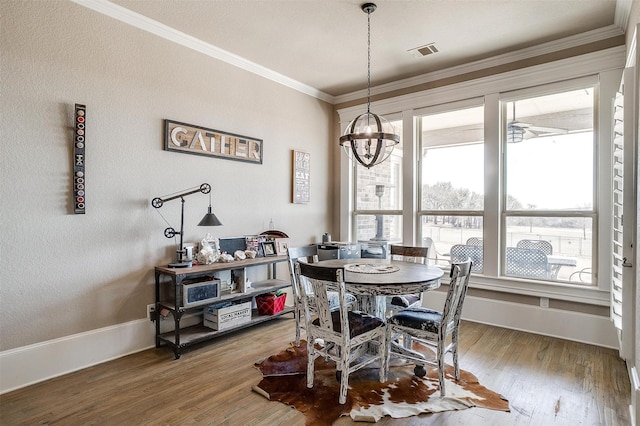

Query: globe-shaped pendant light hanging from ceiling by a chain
[340,3,400,169]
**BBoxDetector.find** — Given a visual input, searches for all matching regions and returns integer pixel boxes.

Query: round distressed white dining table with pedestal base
[316,258,444,318]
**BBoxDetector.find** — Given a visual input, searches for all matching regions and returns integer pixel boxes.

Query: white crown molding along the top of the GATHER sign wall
[71,0,335,104]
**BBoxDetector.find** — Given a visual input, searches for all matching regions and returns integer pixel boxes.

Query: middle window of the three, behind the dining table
[417,106,484,266]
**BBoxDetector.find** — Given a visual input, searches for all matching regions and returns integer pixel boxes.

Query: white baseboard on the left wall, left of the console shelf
[0,318,155,395]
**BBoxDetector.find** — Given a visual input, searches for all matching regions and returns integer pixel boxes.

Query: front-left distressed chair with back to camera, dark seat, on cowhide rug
[295,262,387,404]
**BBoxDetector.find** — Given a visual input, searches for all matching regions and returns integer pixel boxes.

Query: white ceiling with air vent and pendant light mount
[99,0,631,99]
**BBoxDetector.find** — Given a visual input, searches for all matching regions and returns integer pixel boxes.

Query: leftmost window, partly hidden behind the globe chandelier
[354,121,402,242]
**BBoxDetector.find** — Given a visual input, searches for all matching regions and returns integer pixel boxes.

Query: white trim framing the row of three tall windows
[338,46,626,306]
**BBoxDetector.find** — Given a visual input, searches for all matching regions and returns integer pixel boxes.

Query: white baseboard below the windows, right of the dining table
[423,291,618,349]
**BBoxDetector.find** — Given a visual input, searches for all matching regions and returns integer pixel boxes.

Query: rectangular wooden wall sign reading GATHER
[164,120,262,164]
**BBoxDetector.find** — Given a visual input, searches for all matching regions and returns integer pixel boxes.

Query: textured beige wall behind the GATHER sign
[0,0,336,351]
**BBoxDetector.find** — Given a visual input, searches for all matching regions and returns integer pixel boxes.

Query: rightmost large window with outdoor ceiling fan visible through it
[501,87,597,284]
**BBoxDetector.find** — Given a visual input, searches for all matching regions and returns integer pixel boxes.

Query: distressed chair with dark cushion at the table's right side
[384,259,472,396]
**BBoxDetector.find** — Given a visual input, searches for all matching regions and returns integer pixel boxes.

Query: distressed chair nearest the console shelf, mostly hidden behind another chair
[287,244,356,346]
